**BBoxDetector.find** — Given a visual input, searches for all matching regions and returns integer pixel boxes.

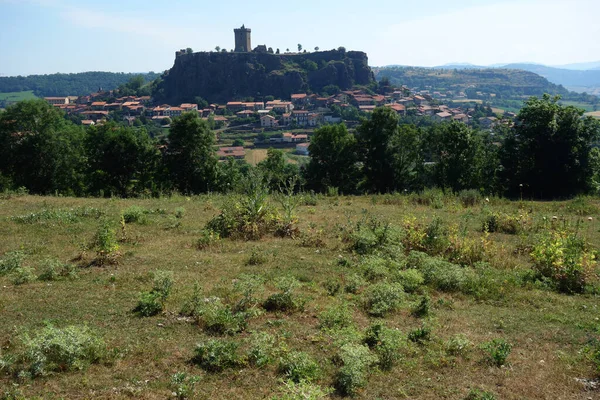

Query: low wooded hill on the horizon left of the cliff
[0,72,159,97]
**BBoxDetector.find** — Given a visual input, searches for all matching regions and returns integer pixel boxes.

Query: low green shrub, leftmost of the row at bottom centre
[192,339,242,372]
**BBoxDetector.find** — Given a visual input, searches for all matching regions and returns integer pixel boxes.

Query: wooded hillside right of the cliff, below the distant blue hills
[374,67,569,98]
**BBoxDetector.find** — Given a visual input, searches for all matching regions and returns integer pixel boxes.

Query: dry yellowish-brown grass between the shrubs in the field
[0,193,600,400]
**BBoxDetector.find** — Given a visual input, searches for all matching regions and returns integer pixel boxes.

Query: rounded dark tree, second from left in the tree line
[85,123,160,197]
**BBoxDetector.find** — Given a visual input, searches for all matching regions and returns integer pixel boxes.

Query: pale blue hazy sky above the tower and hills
[0,0,600,76]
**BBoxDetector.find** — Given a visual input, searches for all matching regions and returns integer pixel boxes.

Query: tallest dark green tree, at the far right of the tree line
[500,94,600,198]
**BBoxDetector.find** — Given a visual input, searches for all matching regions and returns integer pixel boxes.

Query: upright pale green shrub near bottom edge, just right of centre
[335,343,377,396]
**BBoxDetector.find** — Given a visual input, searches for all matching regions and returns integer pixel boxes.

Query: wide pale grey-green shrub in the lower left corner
[20,326,106,377]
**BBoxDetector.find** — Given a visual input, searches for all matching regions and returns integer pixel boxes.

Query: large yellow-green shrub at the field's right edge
[531,232,595,293]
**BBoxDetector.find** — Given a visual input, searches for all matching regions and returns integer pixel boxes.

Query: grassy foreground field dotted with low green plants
[0,192,600,400]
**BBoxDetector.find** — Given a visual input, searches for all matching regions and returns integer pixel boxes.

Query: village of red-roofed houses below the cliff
[45,83,506,159]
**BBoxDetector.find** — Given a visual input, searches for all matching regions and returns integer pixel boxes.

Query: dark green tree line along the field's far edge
[0,95,600,198]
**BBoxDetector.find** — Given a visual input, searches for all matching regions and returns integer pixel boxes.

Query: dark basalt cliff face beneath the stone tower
[154,49,375,104]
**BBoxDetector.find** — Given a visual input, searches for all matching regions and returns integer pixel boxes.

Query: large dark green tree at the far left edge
[0,100,85,195]
